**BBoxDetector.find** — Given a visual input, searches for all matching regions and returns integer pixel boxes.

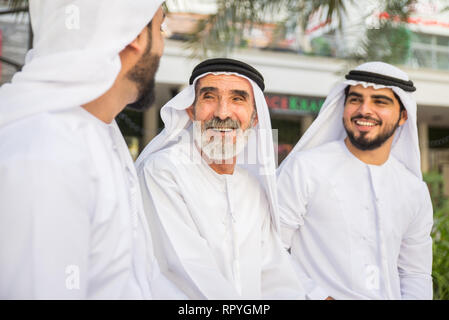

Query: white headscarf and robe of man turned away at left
[0,0,180,299]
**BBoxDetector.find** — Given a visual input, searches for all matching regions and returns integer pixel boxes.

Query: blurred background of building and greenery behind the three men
[0,0,449,299]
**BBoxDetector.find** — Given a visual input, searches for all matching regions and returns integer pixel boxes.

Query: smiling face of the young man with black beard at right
[343,85,407,150]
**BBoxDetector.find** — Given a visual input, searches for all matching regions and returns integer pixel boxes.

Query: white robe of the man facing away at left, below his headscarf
[0,107,178,299]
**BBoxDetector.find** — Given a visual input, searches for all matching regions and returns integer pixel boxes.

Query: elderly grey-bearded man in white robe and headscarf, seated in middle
[136,59,304,299]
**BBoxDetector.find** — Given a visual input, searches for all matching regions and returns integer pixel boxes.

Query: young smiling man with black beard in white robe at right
[278,62,433,299]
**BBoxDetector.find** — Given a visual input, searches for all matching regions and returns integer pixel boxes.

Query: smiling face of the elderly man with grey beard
[187,74,257,160]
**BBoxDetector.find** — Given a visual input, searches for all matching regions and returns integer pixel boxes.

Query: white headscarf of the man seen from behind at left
[0,0,164,128]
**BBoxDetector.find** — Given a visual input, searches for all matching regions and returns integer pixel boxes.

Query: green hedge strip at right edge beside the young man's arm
[424,172,449,300]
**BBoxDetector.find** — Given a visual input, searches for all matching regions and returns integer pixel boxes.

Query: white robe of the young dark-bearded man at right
[278,140,433,299]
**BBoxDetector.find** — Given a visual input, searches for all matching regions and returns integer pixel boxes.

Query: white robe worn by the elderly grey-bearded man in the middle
[138,129,304,299]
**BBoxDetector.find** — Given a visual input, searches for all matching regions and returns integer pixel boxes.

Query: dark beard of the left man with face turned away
[126,48,160,111]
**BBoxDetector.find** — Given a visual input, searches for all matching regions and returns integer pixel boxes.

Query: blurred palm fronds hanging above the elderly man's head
[183,0,355,58]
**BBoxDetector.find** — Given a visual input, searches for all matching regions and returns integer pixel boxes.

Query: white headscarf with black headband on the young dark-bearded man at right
[278,62,422,179]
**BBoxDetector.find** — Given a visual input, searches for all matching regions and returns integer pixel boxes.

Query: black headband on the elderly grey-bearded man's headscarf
[189,58,265,91]
